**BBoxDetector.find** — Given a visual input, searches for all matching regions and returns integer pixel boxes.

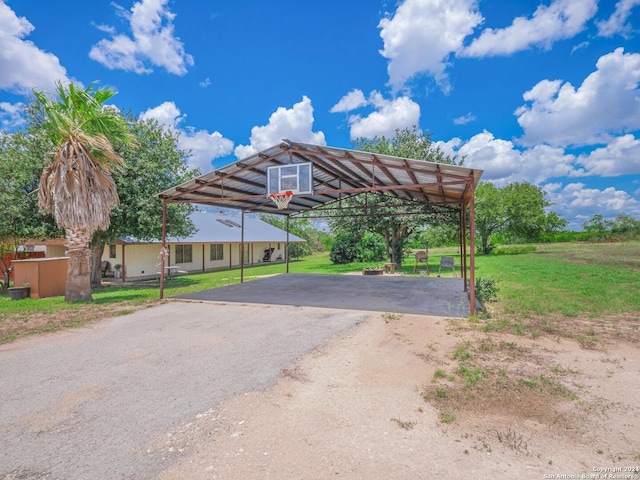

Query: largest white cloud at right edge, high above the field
[515,48,640,145]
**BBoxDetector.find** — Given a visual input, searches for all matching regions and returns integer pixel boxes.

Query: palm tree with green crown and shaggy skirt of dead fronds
[34,82,133,302]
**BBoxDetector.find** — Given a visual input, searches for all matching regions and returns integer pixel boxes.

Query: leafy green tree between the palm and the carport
[91,116,200,287]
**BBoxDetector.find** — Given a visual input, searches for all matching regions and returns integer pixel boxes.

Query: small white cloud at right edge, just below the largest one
[578,134,640,177]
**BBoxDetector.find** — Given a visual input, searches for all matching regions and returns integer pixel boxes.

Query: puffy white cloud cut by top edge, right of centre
[378,0,482,91]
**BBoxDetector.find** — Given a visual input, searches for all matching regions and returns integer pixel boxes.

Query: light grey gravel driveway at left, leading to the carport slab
[0,302,365,480]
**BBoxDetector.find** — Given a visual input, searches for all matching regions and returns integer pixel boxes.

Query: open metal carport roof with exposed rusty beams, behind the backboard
[158,140,482,214]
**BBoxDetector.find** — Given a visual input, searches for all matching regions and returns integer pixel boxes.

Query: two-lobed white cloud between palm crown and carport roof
[140,102,233,173]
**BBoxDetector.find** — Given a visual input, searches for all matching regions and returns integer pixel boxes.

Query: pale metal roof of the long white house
[120,212,306,243]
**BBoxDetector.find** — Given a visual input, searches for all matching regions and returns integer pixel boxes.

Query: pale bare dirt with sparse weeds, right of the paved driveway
[157,314,640,479]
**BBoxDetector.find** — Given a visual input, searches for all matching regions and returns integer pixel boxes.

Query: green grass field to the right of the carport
[476,242,640,317]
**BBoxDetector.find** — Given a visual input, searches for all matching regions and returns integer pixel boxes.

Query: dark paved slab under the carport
[178,273,469,317]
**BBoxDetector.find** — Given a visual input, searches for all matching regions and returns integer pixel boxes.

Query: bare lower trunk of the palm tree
[64,230,93,302]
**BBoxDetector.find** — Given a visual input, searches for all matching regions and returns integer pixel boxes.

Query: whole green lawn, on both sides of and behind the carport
[0,242,640,343]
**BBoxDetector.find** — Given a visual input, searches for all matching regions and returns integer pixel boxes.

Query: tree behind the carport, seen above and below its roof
[329,125,462,265]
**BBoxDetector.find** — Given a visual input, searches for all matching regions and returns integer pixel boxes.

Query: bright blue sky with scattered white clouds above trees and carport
[0,0,640,229]
